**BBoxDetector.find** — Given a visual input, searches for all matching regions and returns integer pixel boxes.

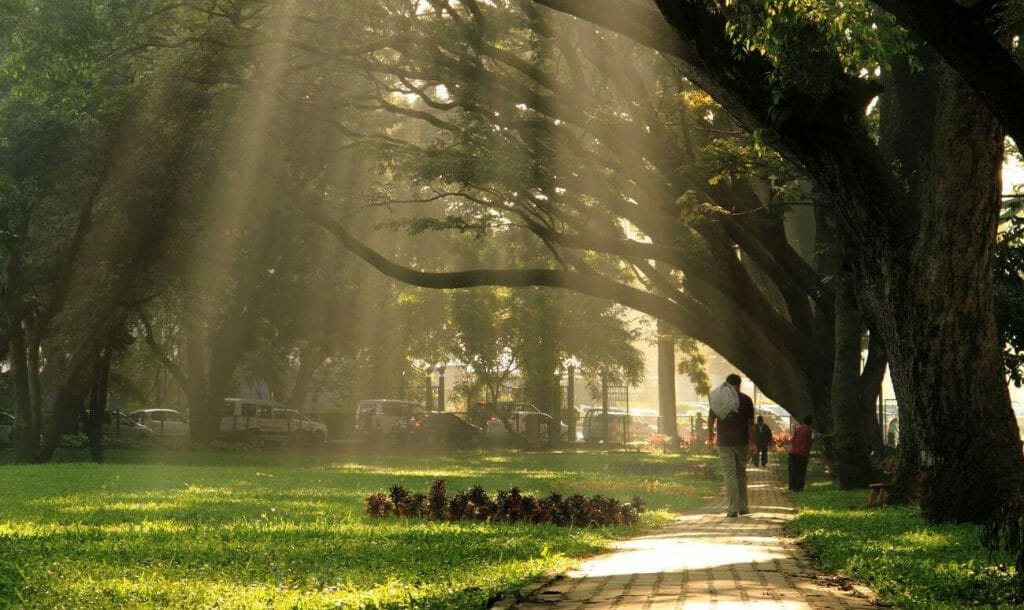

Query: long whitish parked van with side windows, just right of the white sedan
[220,398,311,442]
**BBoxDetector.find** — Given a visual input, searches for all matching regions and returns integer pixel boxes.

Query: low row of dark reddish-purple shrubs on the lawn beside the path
[366,479,644,526]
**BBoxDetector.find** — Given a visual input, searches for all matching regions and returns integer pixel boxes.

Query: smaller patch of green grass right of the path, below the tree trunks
[780,453,1020,609]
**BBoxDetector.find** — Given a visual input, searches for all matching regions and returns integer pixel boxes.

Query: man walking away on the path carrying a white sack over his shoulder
[708,374,755,517]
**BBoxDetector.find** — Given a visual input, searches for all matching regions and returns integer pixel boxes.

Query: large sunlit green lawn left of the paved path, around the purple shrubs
[0,450,718,609]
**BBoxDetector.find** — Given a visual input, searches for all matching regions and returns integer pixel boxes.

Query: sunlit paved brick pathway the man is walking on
[498,463,877,610]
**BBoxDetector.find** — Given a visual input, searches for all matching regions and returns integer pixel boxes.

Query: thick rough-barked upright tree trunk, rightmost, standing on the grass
[867,51,1024,521]
